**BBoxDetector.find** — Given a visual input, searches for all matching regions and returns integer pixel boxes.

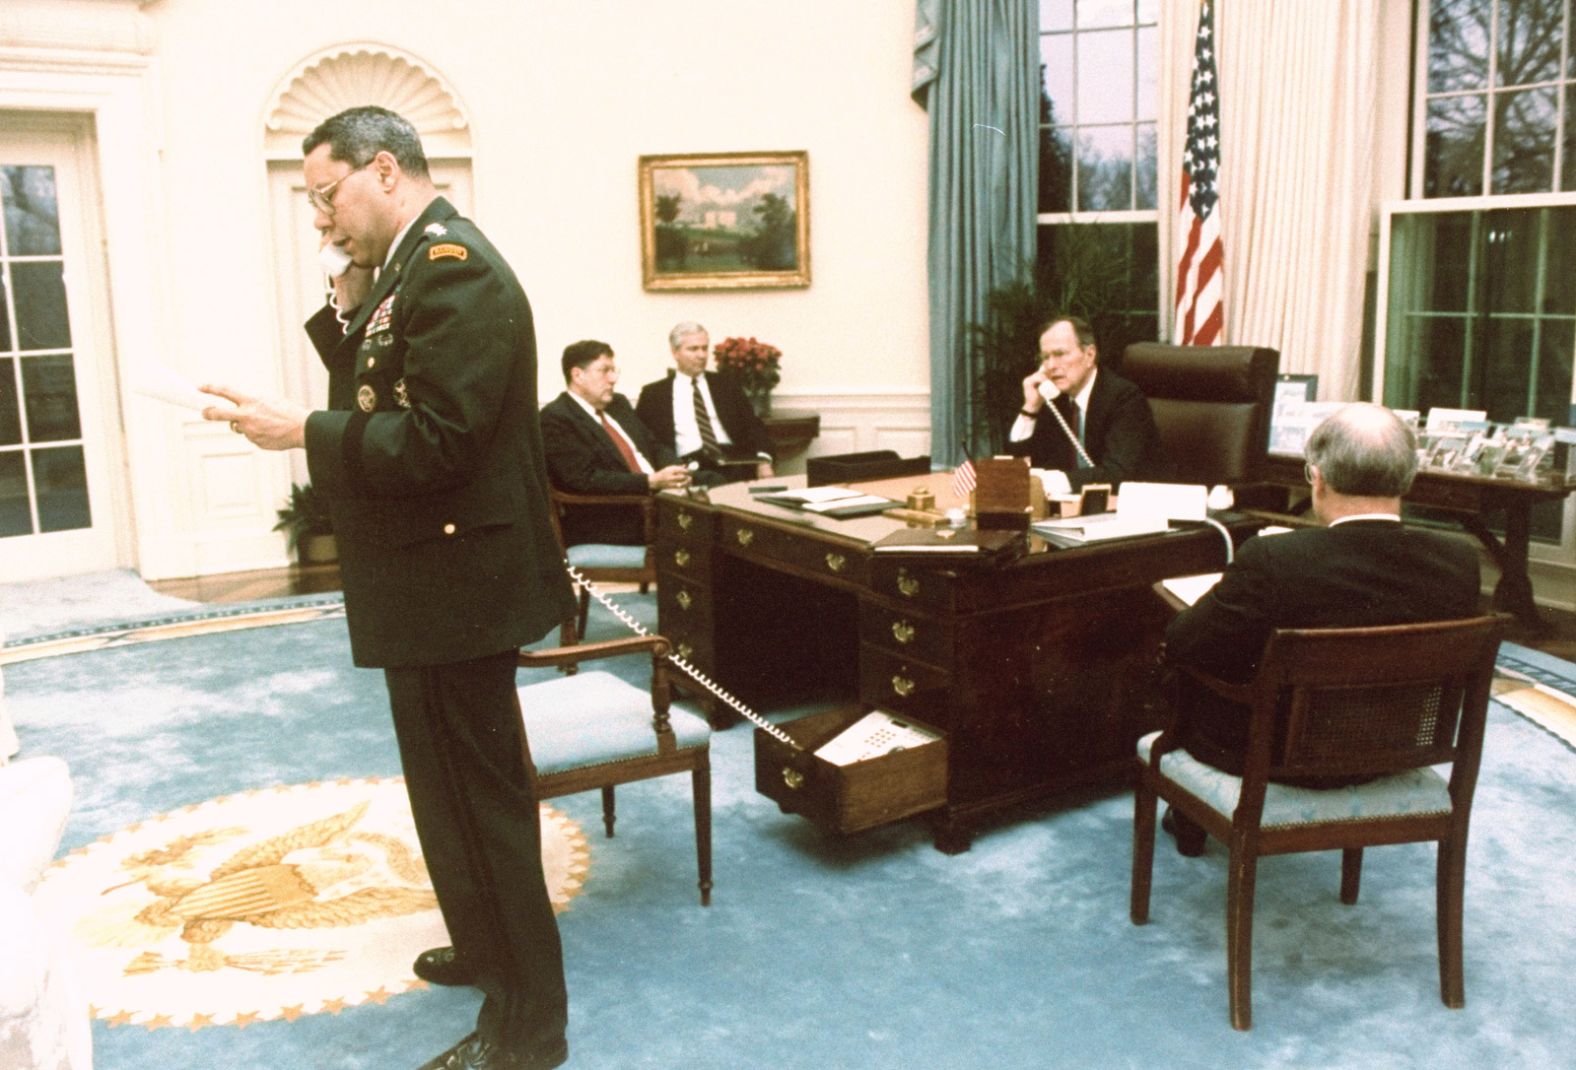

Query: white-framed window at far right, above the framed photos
[1376,0,1576,541]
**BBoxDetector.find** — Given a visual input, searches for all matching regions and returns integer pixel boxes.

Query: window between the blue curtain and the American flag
[1037,0,1160,355]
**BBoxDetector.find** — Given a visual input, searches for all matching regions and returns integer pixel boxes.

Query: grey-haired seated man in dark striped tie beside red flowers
[635,321,772,481]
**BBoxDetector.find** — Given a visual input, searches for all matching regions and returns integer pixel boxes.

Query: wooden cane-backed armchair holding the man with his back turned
[1132,616,1504,1029]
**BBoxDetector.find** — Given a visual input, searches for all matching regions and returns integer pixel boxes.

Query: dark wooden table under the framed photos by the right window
[1264,454,1576,632]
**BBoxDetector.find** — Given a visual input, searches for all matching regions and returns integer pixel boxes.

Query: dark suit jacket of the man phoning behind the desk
[1007,367,1171,490]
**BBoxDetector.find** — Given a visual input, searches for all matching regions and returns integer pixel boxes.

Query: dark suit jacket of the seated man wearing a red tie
[542,391,678,545]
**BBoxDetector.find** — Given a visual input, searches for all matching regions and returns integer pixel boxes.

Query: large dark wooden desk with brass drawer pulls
[657,477,1225,853]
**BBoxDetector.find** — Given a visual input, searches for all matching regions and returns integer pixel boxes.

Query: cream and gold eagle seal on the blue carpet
[36,777,589,1029]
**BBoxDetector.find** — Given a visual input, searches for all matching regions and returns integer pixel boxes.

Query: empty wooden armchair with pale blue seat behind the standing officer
[519,635,711,906]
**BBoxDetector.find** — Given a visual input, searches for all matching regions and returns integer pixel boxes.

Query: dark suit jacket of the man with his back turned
[1166,520,1478,774]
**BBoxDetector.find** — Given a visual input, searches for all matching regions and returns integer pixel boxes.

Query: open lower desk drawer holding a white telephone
[755,706,947,832]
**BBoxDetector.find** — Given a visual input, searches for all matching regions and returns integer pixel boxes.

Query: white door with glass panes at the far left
[0,115,121,581]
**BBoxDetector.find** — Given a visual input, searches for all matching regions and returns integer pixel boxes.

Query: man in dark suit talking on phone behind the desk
[1007,315,1171,490]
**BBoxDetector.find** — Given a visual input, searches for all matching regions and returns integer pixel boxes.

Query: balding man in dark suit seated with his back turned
[1163,403,1480,854]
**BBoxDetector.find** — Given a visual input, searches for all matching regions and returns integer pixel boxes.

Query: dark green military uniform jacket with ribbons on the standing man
[306,197,574,668]
